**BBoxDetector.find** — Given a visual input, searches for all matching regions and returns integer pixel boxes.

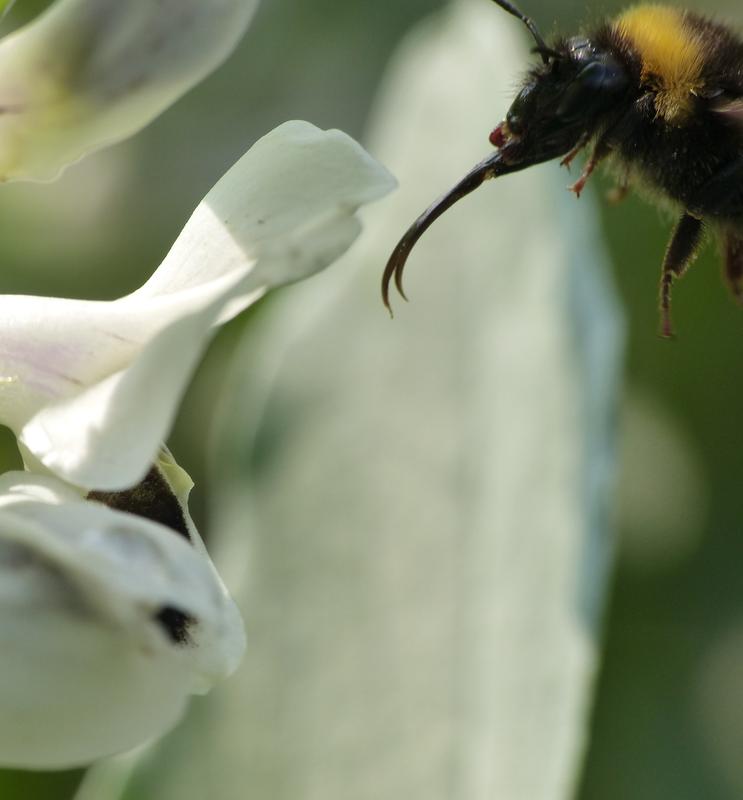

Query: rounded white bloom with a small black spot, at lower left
[0,473,244,768]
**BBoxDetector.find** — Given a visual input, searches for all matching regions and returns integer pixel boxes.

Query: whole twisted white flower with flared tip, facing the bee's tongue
[0,122,394,489]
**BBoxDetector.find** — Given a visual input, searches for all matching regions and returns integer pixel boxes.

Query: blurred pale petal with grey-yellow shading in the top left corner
[0,0,257,180]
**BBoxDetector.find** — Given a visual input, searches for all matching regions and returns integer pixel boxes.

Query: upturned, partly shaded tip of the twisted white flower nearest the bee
[133,120,396,297]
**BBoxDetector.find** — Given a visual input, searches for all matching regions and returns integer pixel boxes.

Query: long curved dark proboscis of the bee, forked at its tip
[382,152,520,314]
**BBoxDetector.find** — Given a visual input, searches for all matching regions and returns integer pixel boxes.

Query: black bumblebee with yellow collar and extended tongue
[382,0,743,337]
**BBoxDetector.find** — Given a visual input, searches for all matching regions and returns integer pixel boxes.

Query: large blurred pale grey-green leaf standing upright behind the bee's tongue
[135,0,621,800]
